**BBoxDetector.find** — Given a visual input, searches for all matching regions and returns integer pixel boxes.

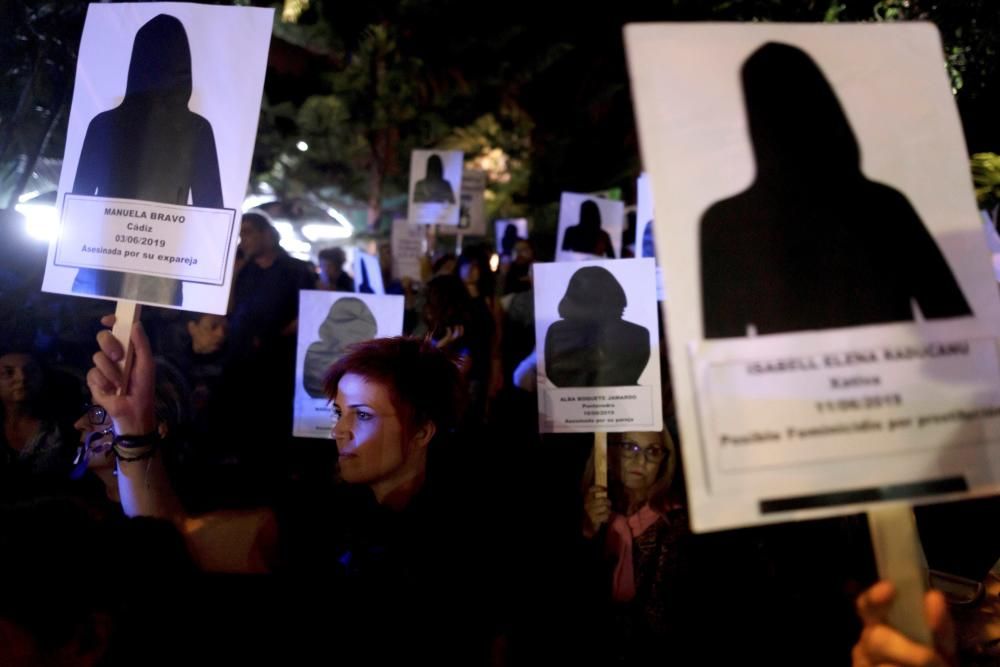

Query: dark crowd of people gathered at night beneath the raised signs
[0,205,1000,667]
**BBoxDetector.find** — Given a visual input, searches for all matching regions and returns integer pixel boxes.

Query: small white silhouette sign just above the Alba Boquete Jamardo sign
[556,192,625,262]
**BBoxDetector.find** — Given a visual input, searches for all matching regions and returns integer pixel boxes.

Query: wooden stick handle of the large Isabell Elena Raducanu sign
[868,503,934,646]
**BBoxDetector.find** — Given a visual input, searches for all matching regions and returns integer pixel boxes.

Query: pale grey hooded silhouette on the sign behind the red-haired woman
[302,296,378,398]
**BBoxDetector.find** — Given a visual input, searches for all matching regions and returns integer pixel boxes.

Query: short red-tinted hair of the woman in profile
[323,336,464,432]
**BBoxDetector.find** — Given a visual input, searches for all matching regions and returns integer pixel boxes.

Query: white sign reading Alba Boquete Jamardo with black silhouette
[534,259,663,433]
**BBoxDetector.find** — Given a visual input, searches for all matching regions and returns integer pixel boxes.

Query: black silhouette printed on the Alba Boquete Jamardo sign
[545,266,650,387]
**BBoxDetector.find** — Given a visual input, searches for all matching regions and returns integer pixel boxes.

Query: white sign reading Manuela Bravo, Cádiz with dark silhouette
[42,3,273,314]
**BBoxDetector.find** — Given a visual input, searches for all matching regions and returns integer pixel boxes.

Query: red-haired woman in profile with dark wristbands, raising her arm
[87,316,496,664]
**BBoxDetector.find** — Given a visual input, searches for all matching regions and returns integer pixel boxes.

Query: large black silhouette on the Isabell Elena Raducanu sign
[701,42,972,338]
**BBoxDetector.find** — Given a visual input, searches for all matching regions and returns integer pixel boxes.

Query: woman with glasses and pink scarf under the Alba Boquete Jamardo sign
[583,431,690,664]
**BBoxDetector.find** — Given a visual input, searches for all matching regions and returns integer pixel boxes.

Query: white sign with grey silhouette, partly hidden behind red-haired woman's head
[292,290,403,439]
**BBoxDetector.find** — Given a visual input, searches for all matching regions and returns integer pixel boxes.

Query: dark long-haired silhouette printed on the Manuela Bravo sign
[73,14,224,306]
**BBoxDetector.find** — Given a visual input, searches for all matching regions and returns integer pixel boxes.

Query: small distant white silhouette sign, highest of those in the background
[406,150,463,226]
